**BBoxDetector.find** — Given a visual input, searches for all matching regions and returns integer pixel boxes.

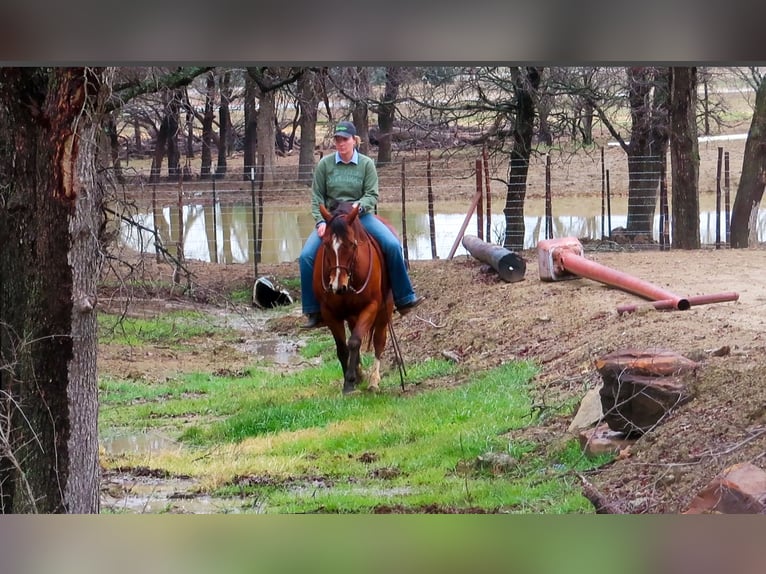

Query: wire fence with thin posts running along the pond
[114,141,766,274]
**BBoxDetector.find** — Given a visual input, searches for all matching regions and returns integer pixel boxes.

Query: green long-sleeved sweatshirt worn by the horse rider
[311,153,378,223]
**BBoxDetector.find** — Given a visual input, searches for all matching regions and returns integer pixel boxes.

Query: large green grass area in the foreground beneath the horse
[100,358,607,513]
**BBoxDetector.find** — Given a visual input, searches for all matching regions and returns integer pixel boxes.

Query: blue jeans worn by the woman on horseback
[298,213,417,314]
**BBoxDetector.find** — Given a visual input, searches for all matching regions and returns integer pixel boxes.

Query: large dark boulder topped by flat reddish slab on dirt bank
[596,349,698,437]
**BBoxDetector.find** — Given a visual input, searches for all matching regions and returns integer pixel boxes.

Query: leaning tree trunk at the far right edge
[731,79,766,248]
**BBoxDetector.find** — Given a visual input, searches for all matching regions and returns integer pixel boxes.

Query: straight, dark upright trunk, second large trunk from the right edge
[670,67,700,249]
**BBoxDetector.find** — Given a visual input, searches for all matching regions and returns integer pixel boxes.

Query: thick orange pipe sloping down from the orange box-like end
[553,250,691,311]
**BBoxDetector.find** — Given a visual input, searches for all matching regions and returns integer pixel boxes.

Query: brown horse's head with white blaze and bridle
[319,202,360,293]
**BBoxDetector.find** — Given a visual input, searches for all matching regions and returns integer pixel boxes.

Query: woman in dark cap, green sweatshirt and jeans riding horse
[299,122,423,329]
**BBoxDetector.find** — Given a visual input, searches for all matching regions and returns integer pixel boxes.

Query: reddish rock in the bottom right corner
[684,462,766,514]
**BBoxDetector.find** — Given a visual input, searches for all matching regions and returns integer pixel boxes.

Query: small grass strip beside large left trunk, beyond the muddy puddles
[98,311,222,347]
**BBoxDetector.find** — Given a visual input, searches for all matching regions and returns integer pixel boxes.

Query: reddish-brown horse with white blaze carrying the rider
[312,202,394,395]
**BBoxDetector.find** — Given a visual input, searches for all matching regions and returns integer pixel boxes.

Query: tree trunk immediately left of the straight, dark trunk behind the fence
[627,68,668,236]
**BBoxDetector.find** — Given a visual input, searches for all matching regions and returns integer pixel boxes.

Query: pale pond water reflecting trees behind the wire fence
[120,194,766,263]
